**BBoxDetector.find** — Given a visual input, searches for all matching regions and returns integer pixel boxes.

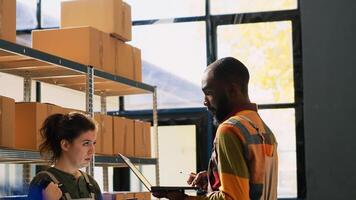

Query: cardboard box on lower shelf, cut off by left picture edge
[0,96,15,148]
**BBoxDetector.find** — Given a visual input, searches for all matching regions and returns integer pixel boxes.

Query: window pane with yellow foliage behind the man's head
[218,21,294,104]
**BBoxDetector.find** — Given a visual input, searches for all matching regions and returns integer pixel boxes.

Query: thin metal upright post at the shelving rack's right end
[152,86,160,185]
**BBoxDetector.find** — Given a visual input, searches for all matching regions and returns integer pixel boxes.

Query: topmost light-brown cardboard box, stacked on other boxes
[61,0,132,41]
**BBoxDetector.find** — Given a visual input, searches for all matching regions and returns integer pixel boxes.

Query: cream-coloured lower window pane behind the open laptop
[131,125,197,191]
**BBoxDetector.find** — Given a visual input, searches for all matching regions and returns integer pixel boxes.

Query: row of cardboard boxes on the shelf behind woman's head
[0,96,151,158]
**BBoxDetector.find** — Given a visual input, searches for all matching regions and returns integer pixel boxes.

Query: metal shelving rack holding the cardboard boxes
[0,40,159,189]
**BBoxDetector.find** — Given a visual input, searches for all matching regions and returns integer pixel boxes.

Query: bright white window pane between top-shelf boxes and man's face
[125,22,206,110]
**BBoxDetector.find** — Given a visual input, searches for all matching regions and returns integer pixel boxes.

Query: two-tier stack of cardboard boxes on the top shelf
[32,0,142,81]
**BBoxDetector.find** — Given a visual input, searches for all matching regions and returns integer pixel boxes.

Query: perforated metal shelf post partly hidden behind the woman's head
[85,66,95,177]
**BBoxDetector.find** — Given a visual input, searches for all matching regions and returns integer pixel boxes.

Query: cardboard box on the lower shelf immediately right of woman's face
[94,114,113,155]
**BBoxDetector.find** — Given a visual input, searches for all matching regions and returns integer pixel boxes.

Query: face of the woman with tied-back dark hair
[63,131,96,169]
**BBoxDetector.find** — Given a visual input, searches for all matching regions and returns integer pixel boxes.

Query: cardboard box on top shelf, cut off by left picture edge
[0,0,16,43]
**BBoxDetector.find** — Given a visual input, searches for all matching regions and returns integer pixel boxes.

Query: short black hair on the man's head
[209,57,250,95]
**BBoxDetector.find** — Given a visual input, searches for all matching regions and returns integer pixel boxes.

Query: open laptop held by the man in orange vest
[119,154,199,193]
